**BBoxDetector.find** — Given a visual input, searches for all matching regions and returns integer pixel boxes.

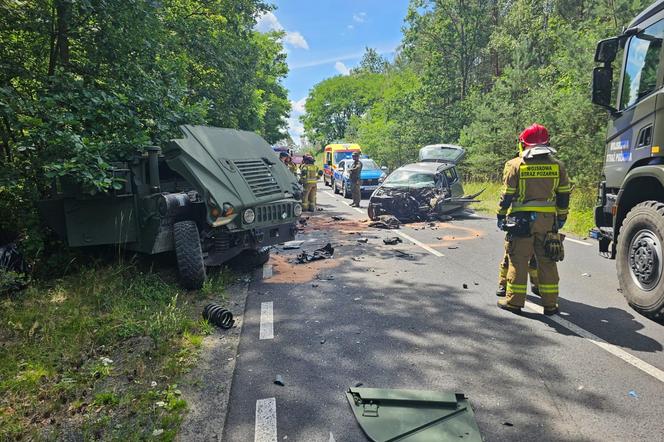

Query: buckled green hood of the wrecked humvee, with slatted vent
[164,125,297,209]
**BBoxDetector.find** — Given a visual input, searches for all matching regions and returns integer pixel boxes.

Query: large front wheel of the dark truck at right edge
[616,201,664,320]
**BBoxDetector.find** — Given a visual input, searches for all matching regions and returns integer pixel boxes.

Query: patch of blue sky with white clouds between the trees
[257,0,408,142]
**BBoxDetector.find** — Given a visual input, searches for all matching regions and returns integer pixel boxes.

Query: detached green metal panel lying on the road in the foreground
[346,388,482,442]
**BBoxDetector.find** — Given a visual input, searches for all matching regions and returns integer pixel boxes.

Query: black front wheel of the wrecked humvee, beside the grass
[173,221,205,290]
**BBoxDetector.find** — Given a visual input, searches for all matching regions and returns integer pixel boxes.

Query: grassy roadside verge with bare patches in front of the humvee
[0,264,229,441]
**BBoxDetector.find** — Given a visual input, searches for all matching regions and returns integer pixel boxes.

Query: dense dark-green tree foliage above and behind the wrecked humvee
[0,0,290,252]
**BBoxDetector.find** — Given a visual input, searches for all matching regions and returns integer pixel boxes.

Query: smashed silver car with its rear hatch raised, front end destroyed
[368,144,482,222]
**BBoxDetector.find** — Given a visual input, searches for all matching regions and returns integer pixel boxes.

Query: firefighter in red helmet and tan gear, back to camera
[498,124,570,315]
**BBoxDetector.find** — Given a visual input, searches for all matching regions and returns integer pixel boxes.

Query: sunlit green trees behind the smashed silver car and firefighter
[304,0,650,184]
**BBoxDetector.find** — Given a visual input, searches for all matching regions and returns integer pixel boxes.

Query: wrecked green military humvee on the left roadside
[40,126,302,289]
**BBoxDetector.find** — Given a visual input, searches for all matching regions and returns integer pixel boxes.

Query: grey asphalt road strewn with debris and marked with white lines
[223,186,664,442]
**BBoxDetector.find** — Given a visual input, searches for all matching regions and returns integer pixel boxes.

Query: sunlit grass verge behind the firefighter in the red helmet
[463,182,595,237]
